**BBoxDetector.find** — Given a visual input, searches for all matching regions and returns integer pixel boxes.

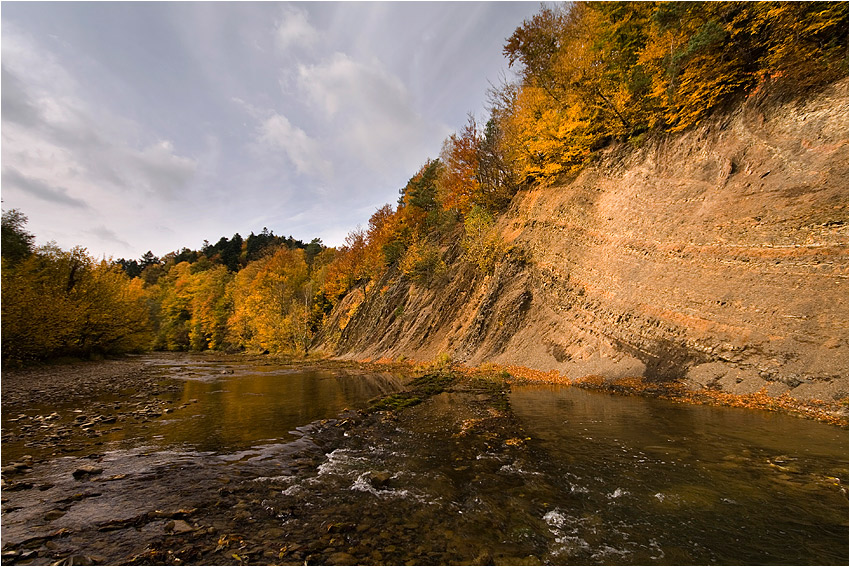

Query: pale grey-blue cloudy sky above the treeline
[0,2,539,259]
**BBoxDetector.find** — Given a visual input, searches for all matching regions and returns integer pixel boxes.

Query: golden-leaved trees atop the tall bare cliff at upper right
[497,2,848,178]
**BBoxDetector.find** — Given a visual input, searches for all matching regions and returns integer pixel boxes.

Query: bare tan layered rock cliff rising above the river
[320,80,850,400]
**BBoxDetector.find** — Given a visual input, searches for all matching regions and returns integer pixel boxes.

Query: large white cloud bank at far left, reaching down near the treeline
[2,20,197,253]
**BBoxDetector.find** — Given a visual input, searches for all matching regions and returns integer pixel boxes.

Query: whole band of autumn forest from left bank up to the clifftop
[2,2,848,364]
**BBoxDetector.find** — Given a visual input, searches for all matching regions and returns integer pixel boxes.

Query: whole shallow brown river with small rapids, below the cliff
[2,357,848,565]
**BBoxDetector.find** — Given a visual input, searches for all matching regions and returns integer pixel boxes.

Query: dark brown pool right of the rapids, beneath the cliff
[511,386,848,565]
